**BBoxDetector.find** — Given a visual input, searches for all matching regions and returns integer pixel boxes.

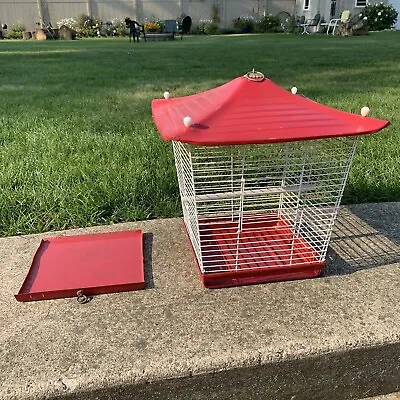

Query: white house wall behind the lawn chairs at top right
[296,0,388,22]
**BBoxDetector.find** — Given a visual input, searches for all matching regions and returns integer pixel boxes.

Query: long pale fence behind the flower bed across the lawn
[0,0,296,31]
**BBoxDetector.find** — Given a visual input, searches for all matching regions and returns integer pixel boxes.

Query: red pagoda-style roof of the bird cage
[151,76,389,146]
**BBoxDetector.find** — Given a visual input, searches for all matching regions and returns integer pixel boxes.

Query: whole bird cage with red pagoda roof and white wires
[152,72,388,288]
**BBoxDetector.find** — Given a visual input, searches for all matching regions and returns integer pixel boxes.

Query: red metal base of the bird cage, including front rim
[183,215,325,289]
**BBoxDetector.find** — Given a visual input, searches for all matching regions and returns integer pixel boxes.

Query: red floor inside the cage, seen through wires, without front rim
[200,214,319,272]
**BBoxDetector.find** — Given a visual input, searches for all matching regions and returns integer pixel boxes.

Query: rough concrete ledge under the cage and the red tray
[0,203,400,400]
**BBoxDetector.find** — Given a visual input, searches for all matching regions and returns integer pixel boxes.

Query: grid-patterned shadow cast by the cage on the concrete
[321,208,400,277]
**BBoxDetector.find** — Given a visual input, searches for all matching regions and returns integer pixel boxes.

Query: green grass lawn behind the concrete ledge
[0,32,400,235]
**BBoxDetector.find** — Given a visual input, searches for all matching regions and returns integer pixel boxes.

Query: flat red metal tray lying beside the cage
[15,230,145,301]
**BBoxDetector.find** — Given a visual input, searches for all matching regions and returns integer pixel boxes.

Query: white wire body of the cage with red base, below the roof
[173,136,357,287]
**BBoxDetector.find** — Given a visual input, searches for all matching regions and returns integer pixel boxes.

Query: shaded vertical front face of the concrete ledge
[53,345,400,400]
